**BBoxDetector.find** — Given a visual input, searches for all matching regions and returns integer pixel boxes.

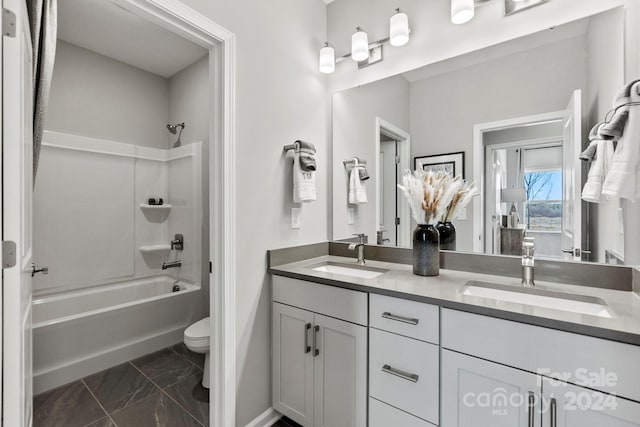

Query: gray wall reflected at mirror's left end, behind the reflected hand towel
[333,76,409,243]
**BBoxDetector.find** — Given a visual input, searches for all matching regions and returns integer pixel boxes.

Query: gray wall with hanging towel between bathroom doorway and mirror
[175,0,331,426]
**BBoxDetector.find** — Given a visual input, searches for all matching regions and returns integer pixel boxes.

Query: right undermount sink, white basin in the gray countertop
[458,280,612,318]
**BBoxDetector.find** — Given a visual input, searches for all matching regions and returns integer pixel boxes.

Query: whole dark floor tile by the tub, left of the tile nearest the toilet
[84,362,158,413]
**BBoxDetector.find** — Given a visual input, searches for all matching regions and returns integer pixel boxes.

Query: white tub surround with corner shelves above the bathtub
[33,131,203,296]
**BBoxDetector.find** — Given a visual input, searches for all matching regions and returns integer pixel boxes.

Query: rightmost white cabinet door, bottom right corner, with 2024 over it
[542,378,640,427]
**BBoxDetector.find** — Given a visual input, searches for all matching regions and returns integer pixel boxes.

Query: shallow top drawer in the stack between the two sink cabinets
[369,294,440,344]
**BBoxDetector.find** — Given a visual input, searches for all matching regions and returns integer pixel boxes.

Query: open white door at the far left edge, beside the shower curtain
[2,0,33,427]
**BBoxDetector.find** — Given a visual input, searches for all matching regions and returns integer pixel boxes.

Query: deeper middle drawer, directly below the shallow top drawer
[369,329,440,424]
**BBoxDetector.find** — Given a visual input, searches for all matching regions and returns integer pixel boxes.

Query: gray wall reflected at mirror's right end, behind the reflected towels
[586,8,624,262]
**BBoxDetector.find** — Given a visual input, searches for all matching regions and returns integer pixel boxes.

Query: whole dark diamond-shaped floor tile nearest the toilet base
[131,348,200,388]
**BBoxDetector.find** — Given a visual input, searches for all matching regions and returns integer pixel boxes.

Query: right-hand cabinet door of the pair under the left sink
[314,314,367,427]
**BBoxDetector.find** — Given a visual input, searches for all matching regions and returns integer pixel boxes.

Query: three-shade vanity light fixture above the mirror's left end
[318,9,411,74]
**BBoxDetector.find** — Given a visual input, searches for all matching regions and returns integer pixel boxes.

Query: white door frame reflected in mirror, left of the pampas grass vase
[375,117,411,246]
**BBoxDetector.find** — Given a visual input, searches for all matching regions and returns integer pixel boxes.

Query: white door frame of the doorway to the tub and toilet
[0,0,236,427]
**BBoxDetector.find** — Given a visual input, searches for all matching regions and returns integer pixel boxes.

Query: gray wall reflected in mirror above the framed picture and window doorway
[410,37,587,251]
